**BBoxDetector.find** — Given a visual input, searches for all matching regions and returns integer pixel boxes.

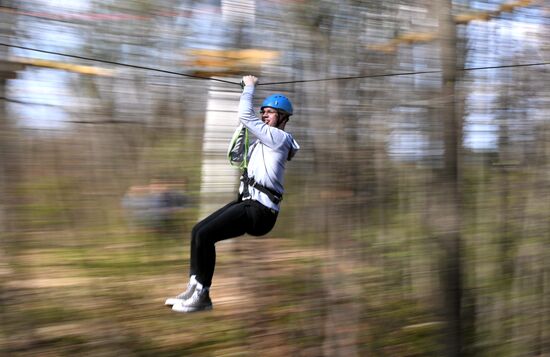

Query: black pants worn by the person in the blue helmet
[189,200,277,286]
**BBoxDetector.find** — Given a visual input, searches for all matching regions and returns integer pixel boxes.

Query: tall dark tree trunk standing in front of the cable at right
[436,0,468,356]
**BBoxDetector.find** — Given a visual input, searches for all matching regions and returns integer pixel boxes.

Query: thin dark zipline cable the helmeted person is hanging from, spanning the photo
[0,43,550,86]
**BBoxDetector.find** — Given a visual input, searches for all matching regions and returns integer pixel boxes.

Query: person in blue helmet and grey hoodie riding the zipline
[165,76,299,312]
